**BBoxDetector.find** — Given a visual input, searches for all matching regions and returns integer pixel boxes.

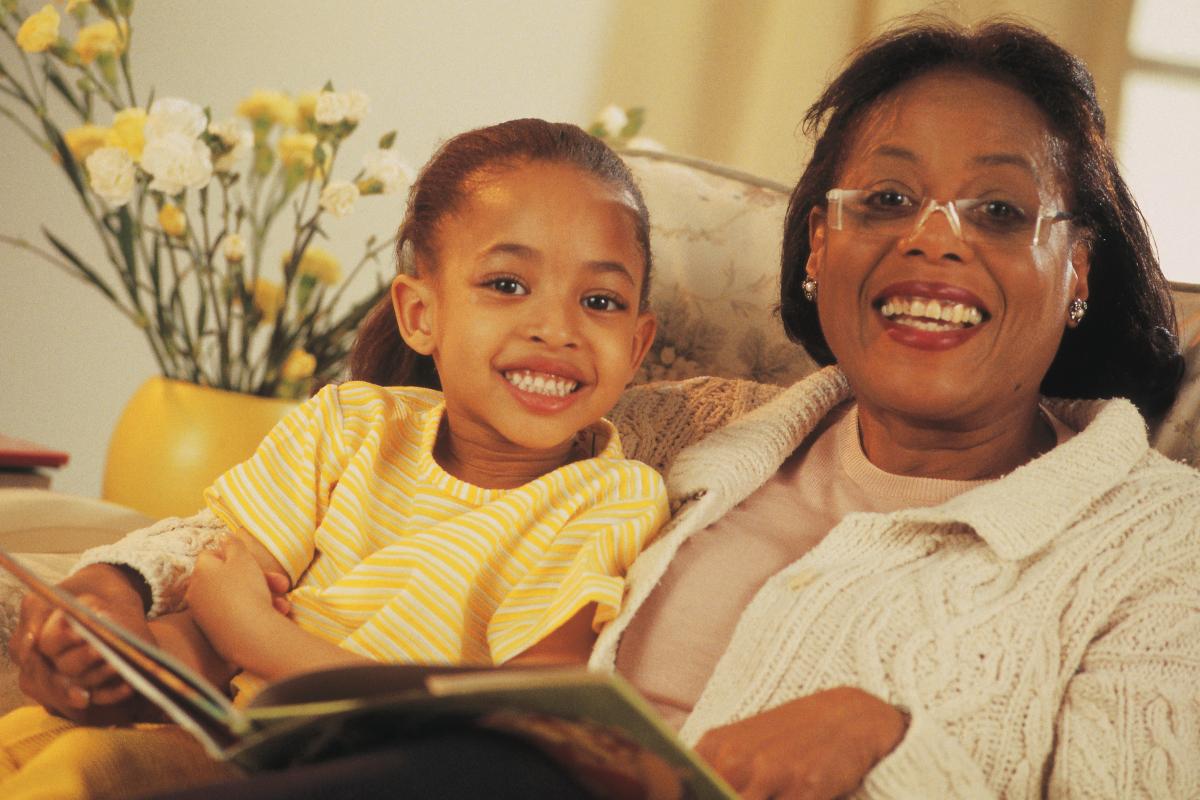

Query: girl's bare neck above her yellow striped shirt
[433,419,584,489]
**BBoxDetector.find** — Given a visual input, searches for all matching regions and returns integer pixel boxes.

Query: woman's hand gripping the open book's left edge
[8,564,157,724]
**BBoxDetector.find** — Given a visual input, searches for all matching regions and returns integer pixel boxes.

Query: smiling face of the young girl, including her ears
[392,162,655,461]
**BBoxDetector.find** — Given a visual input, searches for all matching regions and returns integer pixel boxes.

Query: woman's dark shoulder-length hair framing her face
[780,17,1183,416]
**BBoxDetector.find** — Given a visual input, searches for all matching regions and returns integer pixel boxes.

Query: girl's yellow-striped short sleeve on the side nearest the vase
[204,386,348,584]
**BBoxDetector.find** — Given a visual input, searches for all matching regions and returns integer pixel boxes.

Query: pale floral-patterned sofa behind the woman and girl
[0,150,1200,711]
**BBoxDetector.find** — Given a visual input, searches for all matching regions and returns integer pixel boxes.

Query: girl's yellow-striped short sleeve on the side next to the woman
[487,461,668,664]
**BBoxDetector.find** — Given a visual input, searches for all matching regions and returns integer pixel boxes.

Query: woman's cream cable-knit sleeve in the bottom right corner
[1050,554,1200,798]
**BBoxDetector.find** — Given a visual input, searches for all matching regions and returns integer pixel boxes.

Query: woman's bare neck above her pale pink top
[858,403,1056,481]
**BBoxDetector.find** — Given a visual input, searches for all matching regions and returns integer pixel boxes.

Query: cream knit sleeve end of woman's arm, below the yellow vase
[73,511,229,616]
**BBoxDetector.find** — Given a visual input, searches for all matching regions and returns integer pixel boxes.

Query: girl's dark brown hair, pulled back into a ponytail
[349,119,650,389]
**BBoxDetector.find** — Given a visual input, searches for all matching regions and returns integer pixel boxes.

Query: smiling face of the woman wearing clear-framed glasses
[808,71,1087,428]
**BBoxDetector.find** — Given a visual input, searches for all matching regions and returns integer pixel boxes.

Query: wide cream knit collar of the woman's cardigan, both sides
[667,367,1150,560]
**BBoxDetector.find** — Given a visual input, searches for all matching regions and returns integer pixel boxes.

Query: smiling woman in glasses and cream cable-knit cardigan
[14,23,1200,798]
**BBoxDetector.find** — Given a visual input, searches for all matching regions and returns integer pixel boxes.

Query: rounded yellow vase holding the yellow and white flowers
[101,377,296,518]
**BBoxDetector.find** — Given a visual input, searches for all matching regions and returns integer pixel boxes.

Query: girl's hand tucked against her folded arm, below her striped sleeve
[186,536,278,663]
